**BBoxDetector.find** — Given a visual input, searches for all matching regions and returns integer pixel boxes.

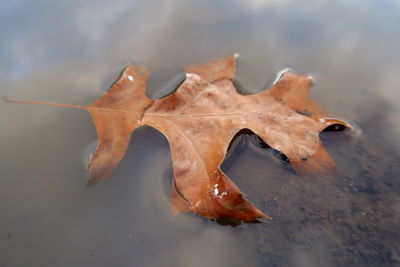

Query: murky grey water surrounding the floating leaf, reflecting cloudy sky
[0,0,400,267]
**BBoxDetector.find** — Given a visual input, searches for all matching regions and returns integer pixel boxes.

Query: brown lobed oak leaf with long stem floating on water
[4,55,352,221]
